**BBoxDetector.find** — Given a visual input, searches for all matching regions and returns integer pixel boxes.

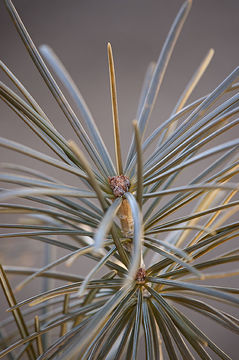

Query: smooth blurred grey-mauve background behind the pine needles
[0,0,239,359]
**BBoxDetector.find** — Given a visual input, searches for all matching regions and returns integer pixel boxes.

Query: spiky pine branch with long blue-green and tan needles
[0,0,239,360]
